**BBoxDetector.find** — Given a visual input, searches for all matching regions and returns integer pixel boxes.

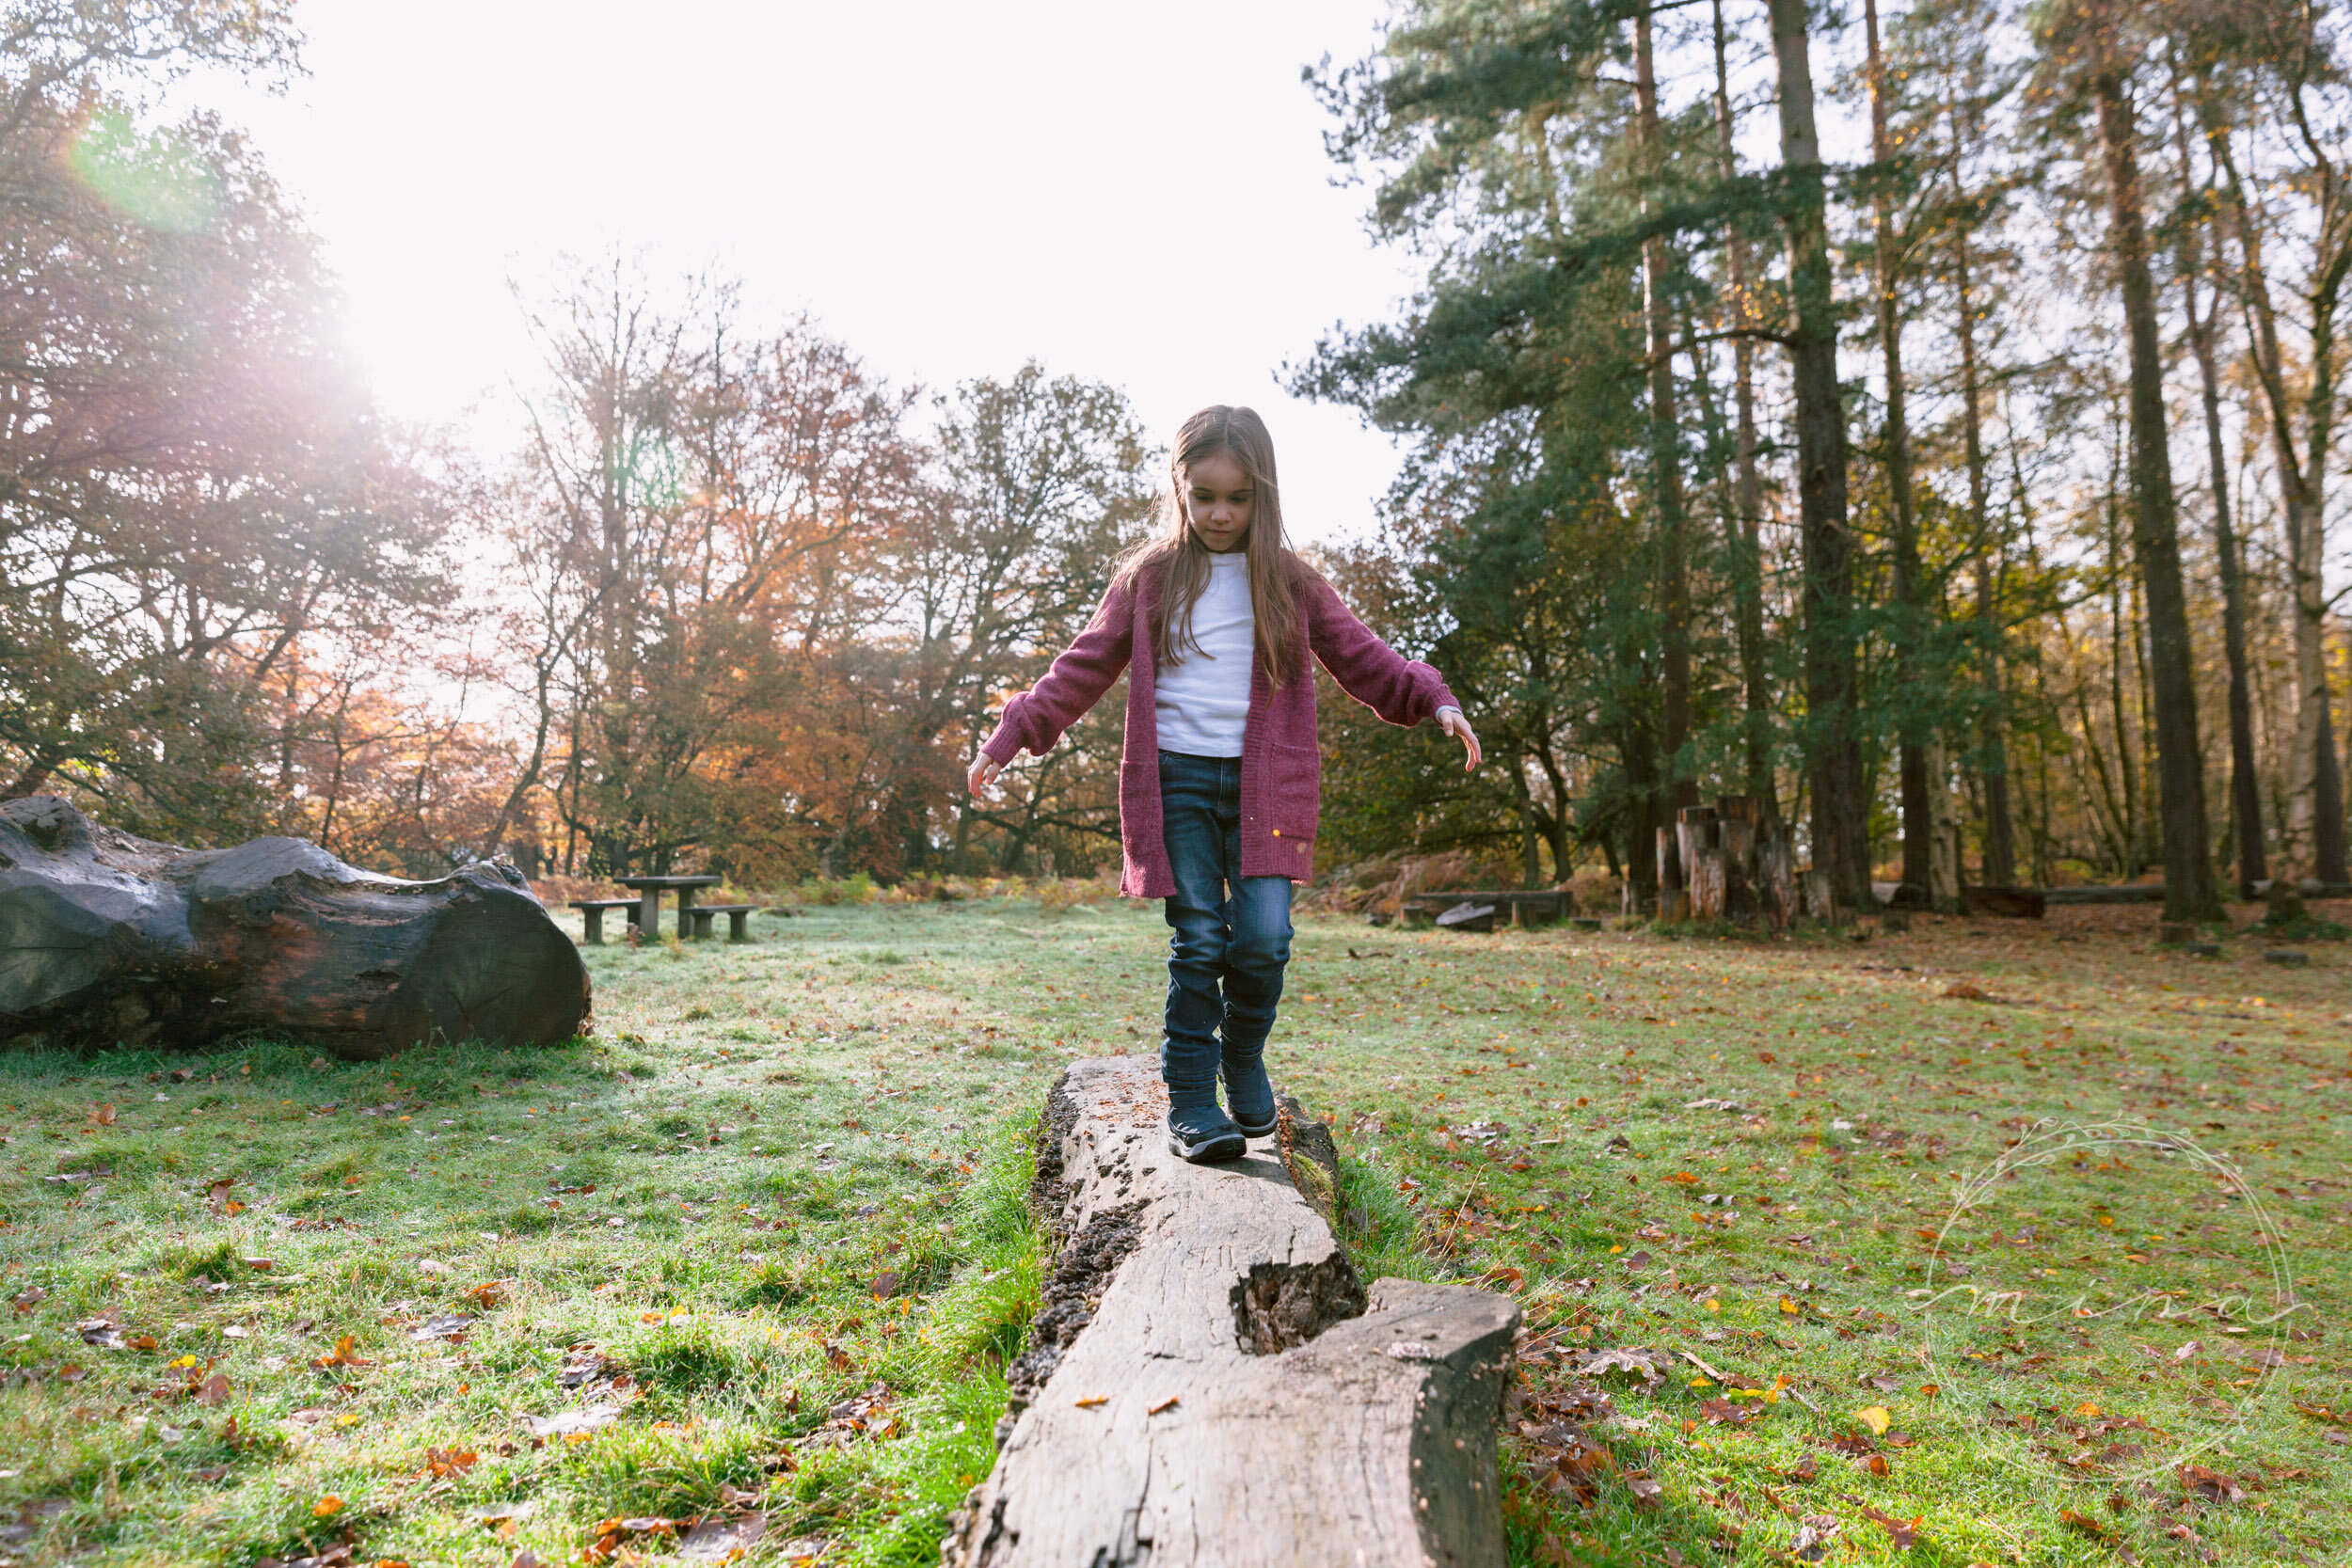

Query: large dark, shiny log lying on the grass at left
[0,795,588,1060]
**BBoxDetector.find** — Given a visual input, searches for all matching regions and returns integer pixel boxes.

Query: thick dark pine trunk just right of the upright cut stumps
[1772,0,1870,910]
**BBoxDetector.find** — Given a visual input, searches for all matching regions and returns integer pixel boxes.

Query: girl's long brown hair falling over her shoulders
[1118,404,1312,687]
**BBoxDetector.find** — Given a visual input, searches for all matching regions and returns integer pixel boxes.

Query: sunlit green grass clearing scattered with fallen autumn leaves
[0,900,2352,1568]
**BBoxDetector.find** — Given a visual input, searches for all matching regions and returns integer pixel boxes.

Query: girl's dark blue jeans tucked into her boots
[1160,752,1292,1110]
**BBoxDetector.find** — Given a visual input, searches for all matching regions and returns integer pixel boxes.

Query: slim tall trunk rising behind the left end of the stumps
[1632,5,1698,891]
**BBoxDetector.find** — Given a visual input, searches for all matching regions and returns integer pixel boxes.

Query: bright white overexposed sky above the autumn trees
[172,0,1414,541]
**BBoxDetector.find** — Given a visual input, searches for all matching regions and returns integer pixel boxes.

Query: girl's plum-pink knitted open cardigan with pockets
[981,574,1461,898]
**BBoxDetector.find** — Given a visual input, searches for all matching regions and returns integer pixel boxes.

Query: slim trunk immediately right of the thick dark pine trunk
[1863,0,1941,905]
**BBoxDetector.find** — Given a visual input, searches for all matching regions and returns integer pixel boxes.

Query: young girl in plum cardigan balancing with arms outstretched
[969,406,1480,1164]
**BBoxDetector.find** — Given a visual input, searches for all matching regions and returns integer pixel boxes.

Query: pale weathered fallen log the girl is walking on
[941,1055,1519,1568]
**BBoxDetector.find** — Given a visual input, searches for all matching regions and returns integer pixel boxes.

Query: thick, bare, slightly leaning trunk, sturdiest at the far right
[2098,49,2223,922]
